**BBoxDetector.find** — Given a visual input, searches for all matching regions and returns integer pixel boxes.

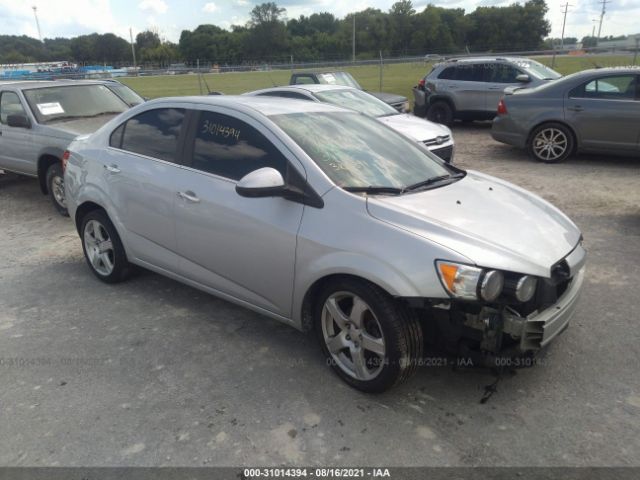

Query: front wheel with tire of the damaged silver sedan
[314,279,423,393]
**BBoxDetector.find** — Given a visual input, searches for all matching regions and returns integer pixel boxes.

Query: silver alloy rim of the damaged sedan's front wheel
[321,292,386,381]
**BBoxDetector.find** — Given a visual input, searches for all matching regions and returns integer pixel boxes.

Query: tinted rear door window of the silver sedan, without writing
[118,108,185,162]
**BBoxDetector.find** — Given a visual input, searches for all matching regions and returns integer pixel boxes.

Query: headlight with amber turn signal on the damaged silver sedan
[436,261,504,302]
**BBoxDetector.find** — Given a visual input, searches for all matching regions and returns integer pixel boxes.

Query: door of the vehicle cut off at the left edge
[0,90,37,175]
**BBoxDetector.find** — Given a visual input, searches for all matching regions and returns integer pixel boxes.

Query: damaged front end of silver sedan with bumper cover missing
[413,243,586,367]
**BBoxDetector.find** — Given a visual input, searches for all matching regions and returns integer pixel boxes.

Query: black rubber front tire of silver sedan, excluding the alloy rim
[313,279,416,393]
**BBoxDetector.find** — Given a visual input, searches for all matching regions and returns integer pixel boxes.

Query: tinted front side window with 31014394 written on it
[191,112,287,180]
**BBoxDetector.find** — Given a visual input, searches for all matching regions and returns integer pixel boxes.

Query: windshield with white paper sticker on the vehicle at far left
[24,85,129,123]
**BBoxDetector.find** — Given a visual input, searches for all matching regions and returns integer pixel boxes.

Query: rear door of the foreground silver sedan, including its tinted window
[103,108,187,272]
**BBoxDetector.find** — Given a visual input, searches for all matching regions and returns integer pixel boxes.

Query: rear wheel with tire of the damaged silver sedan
[80,210,131,283]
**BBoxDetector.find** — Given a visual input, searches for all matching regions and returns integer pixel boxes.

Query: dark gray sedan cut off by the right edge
[491,68,640,163]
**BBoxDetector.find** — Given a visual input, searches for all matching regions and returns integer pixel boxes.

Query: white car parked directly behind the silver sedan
[245,84,454,162]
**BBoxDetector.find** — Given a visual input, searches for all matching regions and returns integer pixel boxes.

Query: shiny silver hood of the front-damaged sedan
[367,171,581,278]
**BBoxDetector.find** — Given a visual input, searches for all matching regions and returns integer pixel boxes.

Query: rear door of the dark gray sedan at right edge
[564,74,640,151]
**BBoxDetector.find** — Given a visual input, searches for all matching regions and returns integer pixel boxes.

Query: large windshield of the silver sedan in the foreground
[270,112,452,189]
